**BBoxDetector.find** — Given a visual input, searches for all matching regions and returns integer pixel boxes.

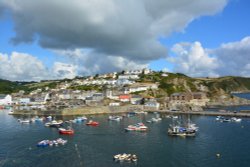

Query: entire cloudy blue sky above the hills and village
[0,0,250,81]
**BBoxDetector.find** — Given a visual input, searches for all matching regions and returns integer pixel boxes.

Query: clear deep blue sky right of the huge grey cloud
[150,0,250,70]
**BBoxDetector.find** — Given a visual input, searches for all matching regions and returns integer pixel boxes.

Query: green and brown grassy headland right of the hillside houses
[140,72,250,97]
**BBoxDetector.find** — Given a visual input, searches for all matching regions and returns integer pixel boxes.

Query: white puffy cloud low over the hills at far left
[0,52,76,81]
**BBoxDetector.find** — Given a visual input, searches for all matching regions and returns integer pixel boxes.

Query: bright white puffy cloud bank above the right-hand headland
[168,37,250,77]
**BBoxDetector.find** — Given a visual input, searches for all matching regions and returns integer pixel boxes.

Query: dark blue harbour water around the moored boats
[0,110,250,167]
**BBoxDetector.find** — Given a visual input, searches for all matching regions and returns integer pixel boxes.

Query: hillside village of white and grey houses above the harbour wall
[0,69,209,114]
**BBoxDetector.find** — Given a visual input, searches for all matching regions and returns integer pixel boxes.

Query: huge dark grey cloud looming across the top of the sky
[0,0,227,61]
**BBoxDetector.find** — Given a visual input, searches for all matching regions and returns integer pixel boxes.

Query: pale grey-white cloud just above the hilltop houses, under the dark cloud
[55,49,148,75]
